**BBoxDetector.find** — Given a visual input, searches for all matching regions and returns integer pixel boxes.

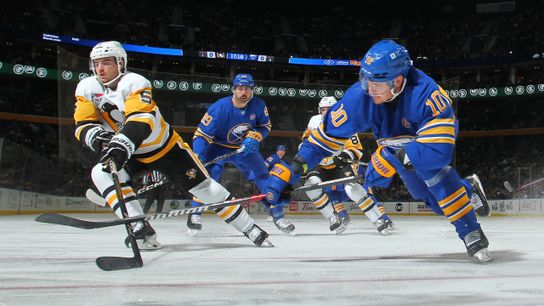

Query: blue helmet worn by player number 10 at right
[359,39,412,90]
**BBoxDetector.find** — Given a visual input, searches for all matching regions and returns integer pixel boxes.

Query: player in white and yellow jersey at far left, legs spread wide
[74,41,271,249]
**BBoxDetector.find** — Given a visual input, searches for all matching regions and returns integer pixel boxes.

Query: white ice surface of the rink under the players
[0,214,544,306]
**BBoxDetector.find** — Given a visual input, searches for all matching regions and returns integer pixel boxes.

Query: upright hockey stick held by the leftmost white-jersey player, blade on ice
[96,159,144,271]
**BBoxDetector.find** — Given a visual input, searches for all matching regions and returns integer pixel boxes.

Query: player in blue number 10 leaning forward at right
[266,40,493,263]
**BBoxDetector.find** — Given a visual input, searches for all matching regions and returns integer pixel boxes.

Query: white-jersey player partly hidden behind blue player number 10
[302,97,393,235]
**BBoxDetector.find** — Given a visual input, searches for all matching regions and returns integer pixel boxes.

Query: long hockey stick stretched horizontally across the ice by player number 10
[36,176,359,229]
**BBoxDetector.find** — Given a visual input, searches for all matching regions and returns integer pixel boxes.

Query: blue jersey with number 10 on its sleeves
[298,68,458,169]
